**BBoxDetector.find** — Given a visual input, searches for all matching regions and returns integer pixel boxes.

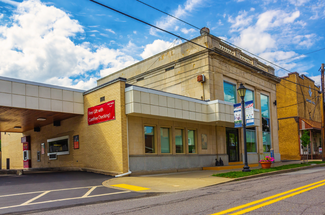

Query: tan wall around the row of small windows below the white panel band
[128,116,219,155]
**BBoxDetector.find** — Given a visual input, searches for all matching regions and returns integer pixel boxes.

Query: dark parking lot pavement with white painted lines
[0,172,146,214]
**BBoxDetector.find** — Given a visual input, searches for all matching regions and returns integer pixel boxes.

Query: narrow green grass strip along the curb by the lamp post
[212,161,325,178]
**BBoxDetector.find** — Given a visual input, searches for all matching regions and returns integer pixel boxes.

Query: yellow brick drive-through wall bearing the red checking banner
[13,82,128,173]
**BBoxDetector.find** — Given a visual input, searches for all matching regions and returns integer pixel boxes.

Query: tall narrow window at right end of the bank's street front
[261,94,272,152]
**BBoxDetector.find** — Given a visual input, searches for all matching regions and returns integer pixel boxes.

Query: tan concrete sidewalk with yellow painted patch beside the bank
[103,161,308,193]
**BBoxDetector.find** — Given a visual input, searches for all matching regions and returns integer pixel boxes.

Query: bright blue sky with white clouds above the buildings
[0,0,325,90]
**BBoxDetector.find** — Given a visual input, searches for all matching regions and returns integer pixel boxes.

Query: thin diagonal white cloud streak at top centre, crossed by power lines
[150,0,204,35]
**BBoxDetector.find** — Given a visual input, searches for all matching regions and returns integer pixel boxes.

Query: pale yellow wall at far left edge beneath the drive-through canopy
[1,132,24,169]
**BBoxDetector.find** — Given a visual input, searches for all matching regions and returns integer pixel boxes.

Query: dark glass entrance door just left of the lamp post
[226,128,239,162]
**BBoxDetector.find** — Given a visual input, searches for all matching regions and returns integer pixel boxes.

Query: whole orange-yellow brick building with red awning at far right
[277,72,322,160]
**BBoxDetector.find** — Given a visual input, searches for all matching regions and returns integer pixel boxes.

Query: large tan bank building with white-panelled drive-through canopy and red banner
[0,32,281,174]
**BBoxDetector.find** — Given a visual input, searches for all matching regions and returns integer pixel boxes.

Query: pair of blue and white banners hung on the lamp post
[234,100,254,128]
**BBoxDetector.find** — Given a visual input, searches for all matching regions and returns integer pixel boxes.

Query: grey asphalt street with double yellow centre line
[28,167,325,215]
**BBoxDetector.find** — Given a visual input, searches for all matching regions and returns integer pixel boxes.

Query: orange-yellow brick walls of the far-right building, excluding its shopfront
[277,73,321,160]
